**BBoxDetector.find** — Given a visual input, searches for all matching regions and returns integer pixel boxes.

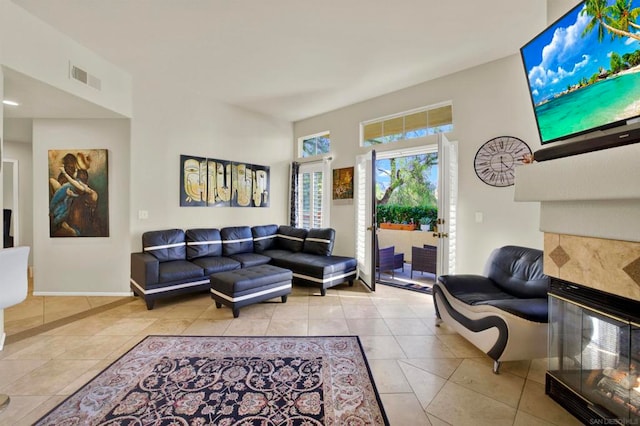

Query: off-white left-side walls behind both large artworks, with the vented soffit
[0,0,293,295]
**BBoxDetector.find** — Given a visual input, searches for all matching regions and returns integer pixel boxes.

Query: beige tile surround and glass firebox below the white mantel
[545,233,640,425]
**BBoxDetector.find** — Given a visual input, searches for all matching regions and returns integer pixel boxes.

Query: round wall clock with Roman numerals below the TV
[473,136,531,187]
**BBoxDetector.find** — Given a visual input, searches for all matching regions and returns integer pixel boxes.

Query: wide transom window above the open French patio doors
[361,103,453,146]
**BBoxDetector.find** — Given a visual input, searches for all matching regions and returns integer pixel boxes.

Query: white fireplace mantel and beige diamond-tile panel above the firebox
[515,144,640,300]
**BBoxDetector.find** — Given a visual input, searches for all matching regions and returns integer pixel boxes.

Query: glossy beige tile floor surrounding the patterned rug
[0,283,580,426]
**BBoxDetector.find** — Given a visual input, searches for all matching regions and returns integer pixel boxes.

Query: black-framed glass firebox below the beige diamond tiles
[546,278,640,425]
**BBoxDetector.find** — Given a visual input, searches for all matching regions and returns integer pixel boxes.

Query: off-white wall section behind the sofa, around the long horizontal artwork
[130,79,293,251]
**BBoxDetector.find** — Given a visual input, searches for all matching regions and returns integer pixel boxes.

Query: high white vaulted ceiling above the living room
[5,0,546,121]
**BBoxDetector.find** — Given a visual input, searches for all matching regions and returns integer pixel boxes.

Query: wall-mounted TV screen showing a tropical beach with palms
[520,0,640,144]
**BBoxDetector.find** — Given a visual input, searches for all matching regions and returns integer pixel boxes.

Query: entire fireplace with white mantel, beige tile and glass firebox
[514,141,640,425]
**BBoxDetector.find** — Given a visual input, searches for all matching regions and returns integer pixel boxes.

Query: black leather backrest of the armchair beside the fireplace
[485,246,549,298]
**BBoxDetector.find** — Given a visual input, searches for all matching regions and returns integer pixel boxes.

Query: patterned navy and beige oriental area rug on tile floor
[36,336,389,426]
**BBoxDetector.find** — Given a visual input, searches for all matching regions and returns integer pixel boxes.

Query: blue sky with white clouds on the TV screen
[522,0,640,105]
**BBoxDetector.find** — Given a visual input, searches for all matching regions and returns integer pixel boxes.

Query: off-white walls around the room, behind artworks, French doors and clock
[0,0,542,294]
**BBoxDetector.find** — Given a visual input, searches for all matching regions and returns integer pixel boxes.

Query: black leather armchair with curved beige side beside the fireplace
[433,246,549,373]
